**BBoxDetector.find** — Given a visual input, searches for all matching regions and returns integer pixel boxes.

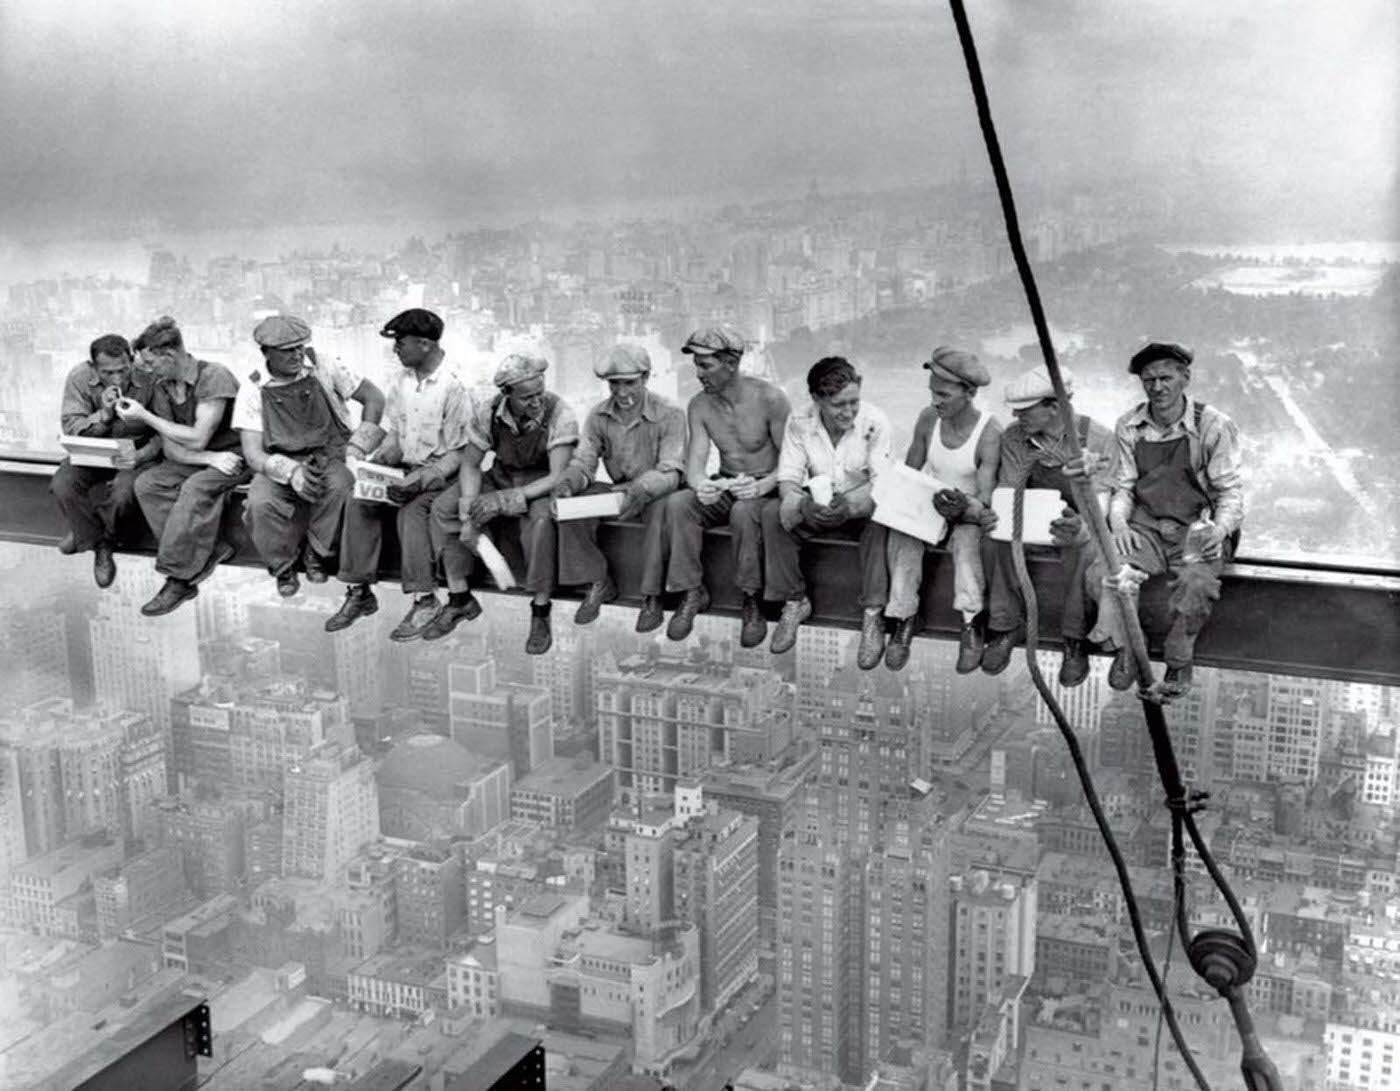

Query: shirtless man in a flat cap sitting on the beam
[666,326,790,648]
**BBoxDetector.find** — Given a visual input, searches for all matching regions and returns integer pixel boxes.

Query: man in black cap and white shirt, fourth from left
[326,307,469,643]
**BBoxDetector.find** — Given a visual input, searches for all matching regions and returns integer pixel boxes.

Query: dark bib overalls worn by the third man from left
[244,373,354,576]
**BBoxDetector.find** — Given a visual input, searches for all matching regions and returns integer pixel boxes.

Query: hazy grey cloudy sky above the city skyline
[0,0,1400,238]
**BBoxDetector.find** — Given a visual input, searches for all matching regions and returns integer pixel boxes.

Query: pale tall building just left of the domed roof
[281,742,379,880]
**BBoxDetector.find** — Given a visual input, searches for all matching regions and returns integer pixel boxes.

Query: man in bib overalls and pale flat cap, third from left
[234,315,384,598]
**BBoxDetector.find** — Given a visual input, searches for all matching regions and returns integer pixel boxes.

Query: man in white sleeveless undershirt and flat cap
[879,346,1001,674]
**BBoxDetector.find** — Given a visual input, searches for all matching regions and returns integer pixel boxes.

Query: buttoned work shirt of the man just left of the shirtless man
[564,391,686,500]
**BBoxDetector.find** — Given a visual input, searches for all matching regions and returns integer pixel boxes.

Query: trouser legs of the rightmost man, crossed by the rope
[1085,518,1233,667]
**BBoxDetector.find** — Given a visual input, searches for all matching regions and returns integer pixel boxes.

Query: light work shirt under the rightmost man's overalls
[1109,395,1245,534]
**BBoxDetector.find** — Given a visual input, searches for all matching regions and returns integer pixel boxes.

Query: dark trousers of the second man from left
[136,458,252,580]
